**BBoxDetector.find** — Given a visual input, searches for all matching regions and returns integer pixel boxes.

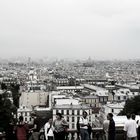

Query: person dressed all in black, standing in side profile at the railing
[107,113,115,140]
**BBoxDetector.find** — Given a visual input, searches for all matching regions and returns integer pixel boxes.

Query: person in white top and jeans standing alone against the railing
[79,111,89,140]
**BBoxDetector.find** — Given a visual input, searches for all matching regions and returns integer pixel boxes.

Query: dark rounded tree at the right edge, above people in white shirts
[119,95,140,115]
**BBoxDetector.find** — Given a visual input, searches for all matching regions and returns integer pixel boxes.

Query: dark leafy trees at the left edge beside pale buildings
[0,83,20,131]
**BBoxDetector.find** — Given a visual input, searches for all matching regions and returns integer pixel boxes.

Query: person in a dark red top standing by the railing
[15,116,29,140]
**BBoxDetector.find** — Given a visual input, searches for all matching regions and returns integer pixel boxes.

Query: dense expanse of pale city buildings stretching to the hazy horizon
[0,60,140,139]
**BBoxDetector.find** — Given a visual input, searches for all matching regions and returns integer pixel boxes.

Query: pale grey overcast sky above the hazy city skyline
[0,0,140,59]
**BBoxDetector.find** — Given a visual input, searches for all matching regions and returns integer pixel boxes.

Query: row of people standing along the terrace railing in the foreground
[3,111,140,140]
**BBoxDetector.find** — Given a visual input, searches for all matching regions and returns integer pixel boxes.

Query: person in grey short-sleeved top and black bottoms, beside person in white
[53,113,68,140]
